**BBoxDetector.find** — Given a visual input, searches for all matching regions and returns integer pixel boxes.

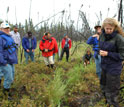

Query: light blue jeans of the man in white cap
[0,64,15,89]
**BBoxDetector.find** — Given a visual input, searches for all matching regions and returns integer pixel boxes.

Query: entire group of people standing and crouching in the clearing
[0,18,124,107]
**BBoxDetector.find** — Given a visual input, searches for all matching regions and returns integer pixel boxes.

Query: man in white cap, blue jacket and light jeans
[0,23,17,99]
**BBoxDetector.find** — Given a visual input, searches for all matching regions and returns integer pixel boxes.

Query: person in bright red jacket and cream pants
[39,32,55,69]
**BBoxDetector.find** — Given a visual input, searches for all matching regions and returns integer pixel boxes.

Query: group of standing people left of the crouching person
[0,22,71,99]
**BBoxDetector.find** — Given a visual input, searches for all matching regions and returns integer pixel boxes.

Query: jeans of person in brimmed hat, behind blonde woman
[95,55,102,79]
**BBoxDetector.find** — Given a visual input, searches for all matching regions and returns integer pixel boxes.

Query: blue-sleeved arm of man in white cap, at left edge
[0,38,7,65]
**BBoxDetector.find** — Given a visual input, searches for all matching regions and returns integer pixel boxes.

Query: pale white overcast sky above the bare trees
[0,0,118,28]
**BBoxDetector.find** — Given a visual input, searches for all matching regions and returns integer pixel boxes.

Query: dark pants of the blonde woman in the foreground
[100,71,120,107]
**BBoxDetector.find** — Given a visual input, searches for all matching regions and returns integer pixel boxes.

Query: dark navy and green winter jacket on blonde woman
[99,32,124,75]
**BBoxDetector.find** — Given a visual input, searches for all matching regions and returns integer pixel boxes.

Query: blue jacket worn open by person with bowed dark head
[22,36,37,50]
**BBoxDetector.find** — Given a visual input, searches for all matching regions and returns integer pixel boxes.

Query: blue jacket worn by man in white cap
[0,31,18,66]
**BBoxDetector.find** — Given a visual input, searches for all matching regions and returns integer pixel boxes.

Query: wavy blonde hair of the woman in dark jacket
[102,18,124,36]
